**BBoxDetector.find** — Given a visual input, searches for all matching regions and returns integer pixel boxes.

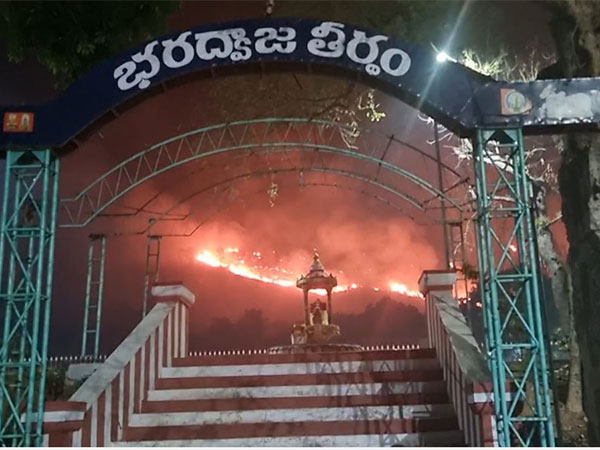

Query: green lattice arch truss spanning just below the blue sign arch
[61,119,461,228]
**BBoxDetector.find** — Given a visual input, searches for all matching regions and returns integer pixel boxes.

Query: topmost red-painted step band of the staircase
[173,348,436,366]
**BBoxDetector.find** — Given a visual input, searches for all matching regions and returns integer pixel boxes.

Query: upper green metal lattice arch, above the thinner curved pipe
[60,118,461,228]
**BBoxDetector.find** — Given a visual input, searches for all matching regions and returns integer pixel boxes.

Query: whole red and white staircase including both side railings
[43,280,497,447]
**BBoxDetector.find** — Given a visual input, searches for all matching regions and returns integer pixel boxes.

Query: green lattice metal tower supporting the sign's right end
[473,129,555,447]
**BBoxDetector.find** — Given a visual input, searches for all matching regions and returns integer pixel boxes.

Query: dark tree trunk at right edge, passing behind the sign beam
[546,0,600,445]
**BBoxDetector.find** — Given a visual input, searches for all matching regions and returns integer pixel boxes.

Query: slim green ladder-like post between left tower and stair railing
[81,234,106,359]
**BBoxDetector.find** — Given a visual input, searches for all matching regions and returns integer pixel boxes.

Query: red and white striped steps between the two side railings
[114,350,464,446]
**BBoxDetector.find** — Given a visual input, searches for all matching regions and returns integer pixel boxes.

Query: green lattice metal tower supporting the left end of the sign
[0,150,59,446]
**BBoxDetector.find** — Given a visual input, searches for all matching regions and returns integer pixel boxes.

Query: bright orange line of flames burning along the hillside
[196,247,423,298]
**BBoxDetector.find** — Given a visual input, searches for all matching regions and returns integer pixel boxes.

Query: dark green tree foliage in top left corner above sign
[0,1,179,86]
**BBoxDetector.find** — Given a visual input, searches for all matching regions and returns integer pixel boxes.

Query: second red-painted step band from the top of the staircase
[156,368,444,389]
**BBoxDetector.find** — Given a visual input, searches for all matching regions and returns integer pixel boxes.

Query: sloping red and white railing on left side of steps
[44,284,195,447]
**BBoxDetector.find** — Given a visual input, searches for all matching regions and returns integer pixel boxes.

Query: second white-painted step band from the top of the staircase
[148,379,446,401]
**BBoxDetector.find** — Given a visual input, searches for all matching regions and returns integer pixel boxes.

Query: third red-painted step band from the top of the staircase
[142,391,449,413]
